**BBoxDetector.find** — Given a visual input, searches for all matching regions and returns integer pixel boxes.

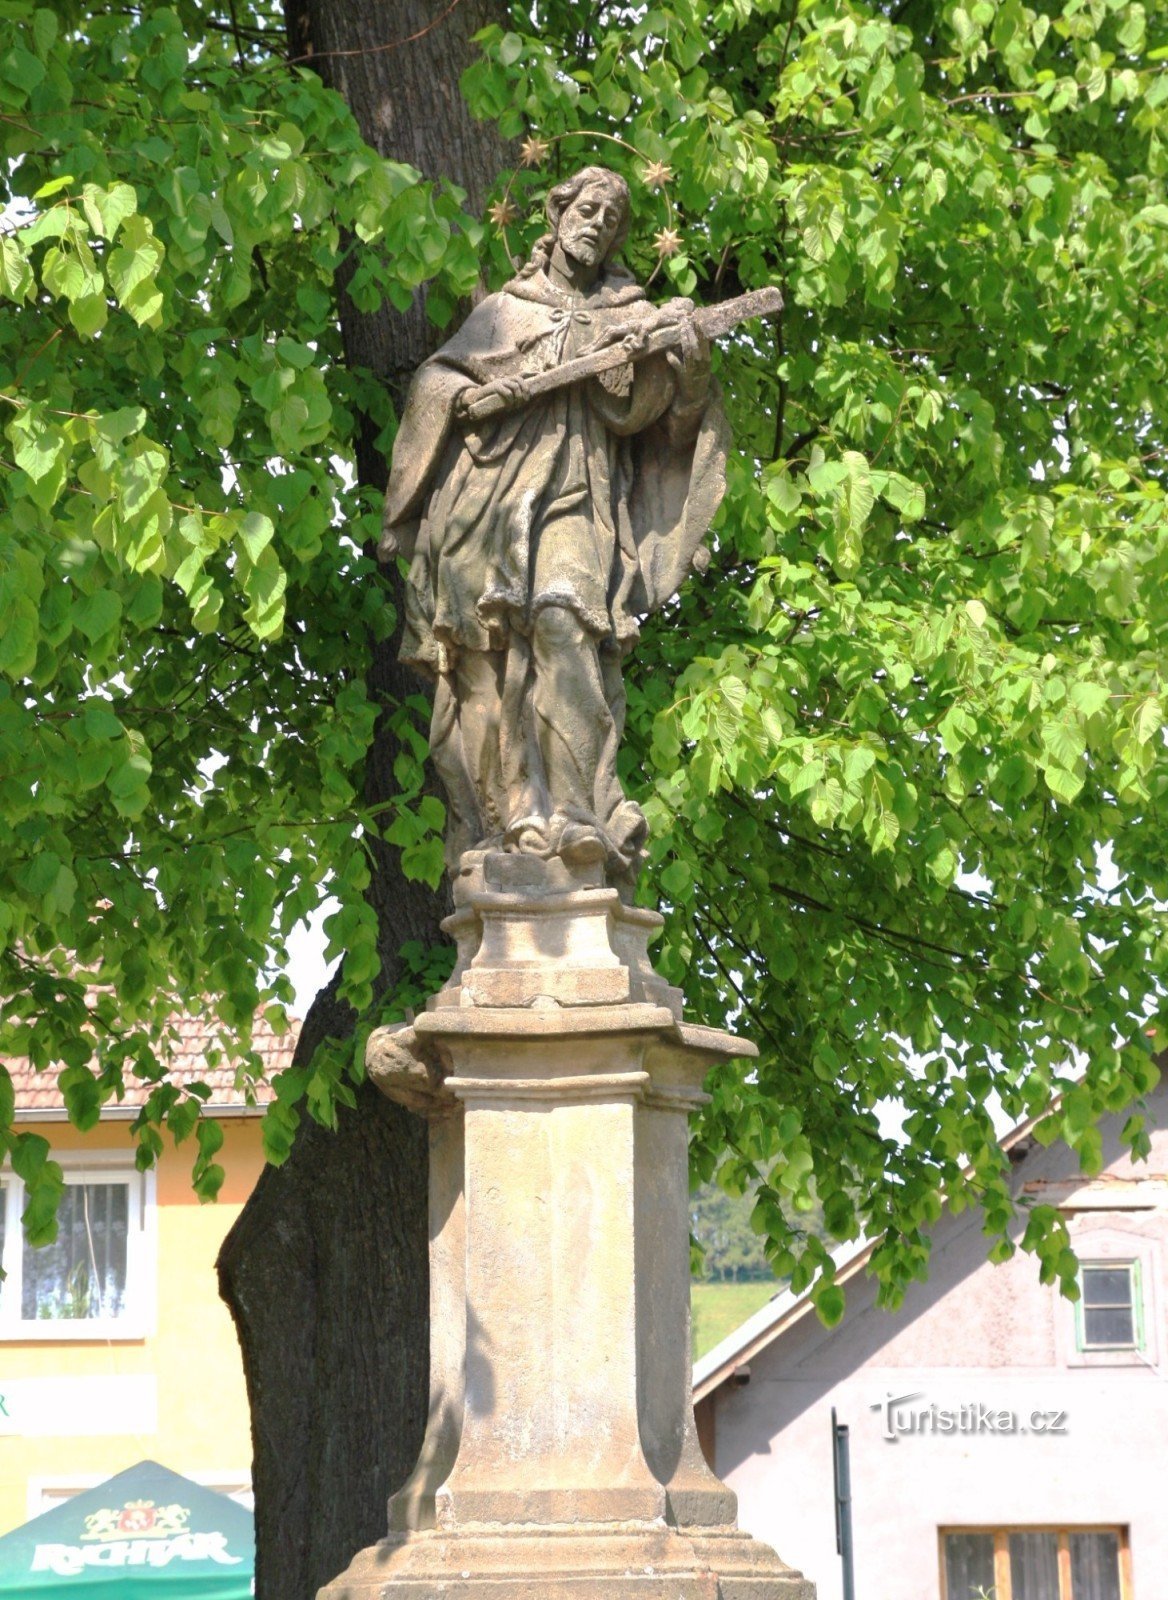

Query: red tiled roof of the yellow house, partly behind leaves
[0,1016,299,1117]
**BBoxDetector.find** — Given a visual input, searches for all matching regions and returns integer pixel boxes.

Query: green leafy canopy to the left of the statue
[0,0,482,1237]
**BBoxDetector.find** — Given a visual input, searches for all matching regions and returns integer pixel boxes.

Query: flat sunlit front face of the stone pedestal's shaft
[438,1068,664,1526]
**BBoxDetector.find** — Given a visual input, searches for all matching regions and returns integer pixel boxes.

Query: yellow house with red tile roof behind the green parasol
[0,1018,296,1534]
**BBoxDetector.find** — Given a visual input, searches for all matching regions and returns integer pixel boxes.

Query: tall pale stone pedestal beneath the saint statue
[318,853,814,1600]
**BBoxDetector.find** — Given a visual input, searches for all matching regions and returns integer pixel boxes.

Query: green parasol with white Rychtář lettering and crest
[0,1461,256,1600]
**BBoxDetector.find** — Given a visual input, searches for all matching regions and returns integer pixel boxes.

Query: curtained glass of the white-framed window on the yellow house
[21,1182,130,1322]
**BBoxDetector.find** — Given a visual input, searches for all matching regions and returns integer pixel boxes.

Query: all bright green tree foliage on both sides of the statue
[0,0,1168,1320]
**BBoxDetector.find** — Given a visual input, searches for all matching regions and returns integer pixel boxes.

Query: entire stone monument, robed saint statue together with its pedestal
[320,168,813,1600]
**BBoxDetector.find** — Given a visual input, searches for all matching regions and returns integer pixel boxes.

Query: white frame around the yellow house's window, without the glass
[0,1150,158,1344]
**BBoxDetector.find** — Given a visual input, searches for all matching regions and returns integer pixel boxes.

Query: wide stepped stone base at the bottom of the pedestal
[318,1523,814,1600]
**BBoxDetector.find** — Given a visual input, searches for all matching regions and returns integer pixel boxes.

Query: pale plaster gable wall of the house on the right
[714,1093,1168,1600]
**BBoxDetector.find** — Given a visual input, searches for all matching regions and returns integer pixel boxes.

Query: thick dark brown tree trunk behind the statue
[219,0,507,1600]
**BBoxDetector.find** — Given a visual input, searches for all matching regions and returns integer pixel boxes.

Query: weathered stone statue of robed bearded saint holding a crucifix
[381,166,726,885]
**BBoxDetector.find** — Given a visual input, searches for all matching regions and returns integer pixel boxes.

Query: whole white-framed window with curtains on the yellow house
[0,1154,154,1339]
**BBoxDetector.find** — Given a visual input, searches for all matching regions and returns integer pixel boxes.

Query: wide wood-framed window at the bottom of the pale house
[941,1528,1133,1600]
